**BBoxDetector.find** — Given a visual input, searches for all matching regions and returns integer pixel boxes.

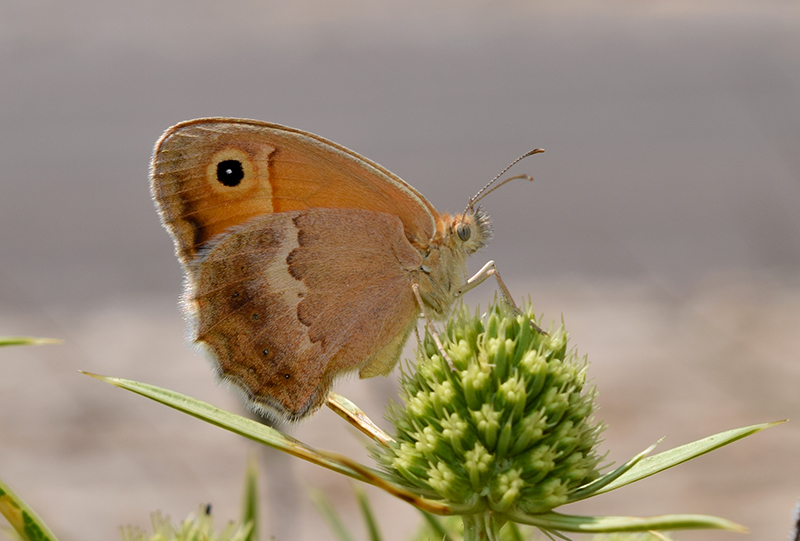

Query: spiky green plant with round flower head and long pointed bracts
[84,302,778,541]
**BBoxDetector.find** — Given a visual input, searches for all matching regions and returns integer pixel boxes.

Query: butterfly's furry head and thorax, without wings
[415,208,492,319]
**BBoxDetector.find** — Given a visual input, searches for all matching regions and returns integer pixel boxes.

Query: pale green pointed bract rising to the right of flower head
[591,421,786,496]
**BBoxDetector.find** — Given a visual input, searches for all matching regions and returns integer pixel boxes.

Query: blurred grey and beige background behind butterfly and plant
[0,0,800,541]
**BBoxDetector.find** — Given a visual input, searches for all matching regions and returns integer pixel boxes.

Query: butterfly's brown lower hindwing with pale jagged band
[191,208,421,420]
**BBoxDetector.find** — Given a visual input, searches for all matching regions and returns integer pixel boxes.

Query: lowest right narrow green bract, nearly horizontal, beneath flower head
[508,512,747,533]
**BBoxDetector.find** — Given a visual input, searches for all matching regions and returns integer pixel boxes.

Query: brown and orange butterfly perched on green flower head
[151,118,542,421]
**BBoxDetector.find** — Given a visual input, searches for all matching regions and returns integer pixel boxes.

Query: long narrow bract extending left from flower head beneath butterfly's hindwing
[82,372,378,483]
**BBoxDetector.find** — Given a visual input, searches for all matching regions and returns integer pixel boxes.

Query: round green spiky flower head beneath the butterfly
[374,303,602,514]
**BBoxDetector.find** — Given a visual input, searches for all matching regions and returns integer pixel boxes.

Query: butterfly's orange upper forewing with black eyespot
[151,118,437,264]
